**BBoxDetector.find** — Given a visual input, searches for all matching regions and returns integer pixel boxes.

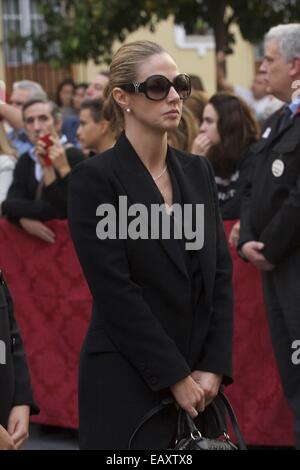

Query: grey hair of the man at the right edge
[265,23,300,63]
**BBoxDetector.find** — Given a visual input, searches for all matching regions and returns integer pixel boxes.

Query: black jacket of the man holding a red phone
[2,147,84,223]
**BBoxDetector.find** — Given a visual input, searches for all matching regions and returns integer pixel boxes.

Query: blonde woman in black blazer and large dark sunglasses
[69,41,232,449]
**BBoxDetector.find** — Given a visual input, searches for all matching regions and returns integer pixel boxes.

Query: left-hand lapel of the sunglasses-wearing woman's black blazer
[115,134,188,278]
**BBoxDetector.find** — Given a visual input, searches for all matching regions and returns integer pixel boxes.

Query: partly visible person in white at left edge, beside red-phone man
[0,122,17,211]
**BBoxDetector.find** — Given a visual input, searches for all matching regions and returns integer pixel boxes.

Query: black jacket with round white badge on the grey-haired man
[239,110,300,264]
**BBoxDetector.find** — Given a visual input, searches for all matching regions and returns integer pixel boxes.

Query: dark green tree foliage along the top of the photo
[11,0,300,66]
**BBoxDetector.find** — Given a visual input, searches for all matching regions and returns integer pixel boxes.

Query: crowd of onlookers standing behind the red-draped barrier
[0,71,281,242]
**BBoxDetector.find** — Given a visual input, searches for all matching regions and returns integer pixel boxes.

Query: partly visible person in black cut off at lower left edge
[0,270,39,450]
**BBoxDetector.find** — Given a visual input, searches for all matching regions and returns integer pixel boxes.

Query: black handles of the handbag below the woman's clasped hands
[128,391,247,450]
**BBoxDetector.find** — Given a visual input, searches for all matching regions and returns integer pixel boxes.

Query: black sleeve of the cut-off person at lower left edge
[0,271,39,427]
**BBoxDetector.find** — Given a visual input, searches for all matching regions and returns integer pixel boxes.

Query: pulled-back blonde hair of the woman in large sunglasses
[104,41,166,134]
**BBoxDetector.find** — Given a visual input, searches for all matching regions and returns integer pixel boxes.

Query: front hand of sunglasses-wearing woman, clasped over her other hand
[170,375,205,418]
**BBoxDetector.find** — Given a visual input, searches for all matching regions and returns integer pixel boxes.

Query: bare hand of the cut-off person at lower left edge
[7,405,30,449]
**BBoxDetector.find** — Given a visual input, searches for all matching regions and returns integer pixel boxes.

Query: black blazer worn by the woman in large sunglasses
[68,135,233,448]
